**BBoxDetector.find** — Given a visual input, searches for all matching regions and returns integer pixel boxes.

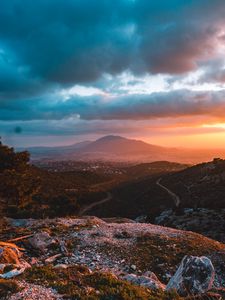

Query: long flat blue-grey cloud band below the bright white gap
[0,90,225,121]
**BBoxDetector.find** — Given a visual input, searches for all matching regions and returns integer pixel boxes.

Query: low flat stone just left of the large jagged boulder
[122,272,165,290]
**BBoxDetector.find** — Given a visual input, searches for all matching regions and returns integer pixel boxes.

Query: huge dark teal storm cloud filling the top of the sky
[0,0,225,94]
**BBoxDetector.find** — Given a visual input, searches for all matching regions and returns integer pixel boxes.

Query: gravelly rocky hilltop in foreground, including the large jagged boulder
[0,217,225,299]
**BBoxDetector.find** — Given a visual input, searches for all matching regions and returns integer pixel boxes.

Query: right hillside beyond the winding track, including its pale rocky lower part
[150,159,225,242]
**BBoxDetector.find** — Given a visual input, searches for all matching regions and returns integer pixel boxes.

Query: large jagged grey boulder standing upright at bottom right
[166,256,215,297]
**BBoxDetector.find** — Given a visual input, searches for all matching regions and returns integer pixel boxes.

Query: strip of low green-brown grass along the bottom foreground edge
[23,266,181,300]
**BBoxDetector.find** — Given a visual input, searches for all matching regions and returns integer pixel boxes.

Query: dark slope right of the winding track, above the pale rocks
[162,159,225,209]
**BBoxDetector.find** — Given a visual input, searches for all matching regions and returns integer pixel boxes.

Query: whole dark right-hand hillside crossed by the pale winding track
[86,159,225,242]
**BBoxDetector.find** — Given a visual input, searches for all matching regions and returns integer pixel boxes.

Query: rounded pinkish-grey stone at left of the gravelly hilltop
[28,231,56,253]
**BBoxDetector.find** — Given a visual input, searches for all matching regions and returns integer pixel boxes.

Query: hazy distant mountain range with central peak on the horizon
[17,135,225,164]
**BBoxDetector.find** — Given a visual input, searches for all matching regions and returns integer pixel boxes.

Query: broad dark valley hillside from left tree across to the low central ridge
[0,139,190,218]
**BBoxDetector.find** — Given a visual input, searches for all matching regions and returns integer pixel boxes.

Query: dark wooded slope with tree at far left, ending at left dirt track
[0,143,108,218]
